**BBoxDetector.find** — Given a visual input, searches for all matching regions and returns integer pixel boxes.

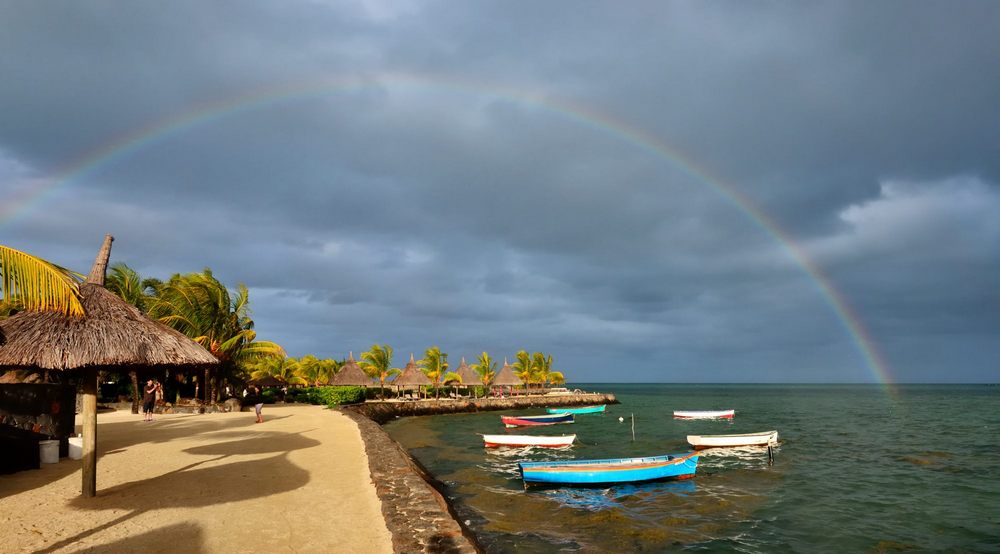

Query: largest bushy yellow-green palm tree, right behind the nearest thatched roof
[149,268,285,402]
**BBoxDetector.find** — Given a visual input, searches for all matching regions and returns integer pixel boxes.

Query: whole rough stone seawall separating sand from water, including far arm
[341,393,618,553]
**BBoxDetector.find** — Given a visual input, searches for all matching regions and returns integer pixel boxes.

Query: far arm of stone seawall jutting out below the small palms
[343,392,618,425]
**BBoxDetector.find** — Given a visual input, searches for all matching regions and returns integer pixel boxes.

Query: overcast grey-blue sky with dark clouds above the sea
[0,0,1000,382]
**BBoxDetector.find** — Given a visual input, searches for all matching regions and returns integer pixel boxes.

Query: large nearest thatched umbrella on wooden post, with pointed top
[0,235,219,496]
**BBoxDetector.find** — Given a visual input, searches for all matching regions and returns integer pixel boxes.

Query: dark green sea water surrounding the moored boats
[386,384,1000,552]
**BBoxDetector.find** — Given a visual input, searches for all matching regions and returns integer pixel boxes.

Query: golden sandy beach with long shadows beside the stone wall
[0,406,393,553]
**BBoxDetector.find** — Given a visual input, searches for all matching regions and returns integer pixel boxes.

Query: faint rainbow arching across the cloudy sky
[0,73,893,384]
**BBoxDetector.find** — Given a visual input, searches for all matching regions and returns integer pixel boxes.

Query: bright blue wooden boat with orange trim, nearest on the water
[517,452,698,487]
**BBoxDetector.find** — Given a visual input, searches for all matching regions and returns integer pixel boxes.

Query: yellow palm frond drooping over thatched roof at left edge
[0,245,84,317]
